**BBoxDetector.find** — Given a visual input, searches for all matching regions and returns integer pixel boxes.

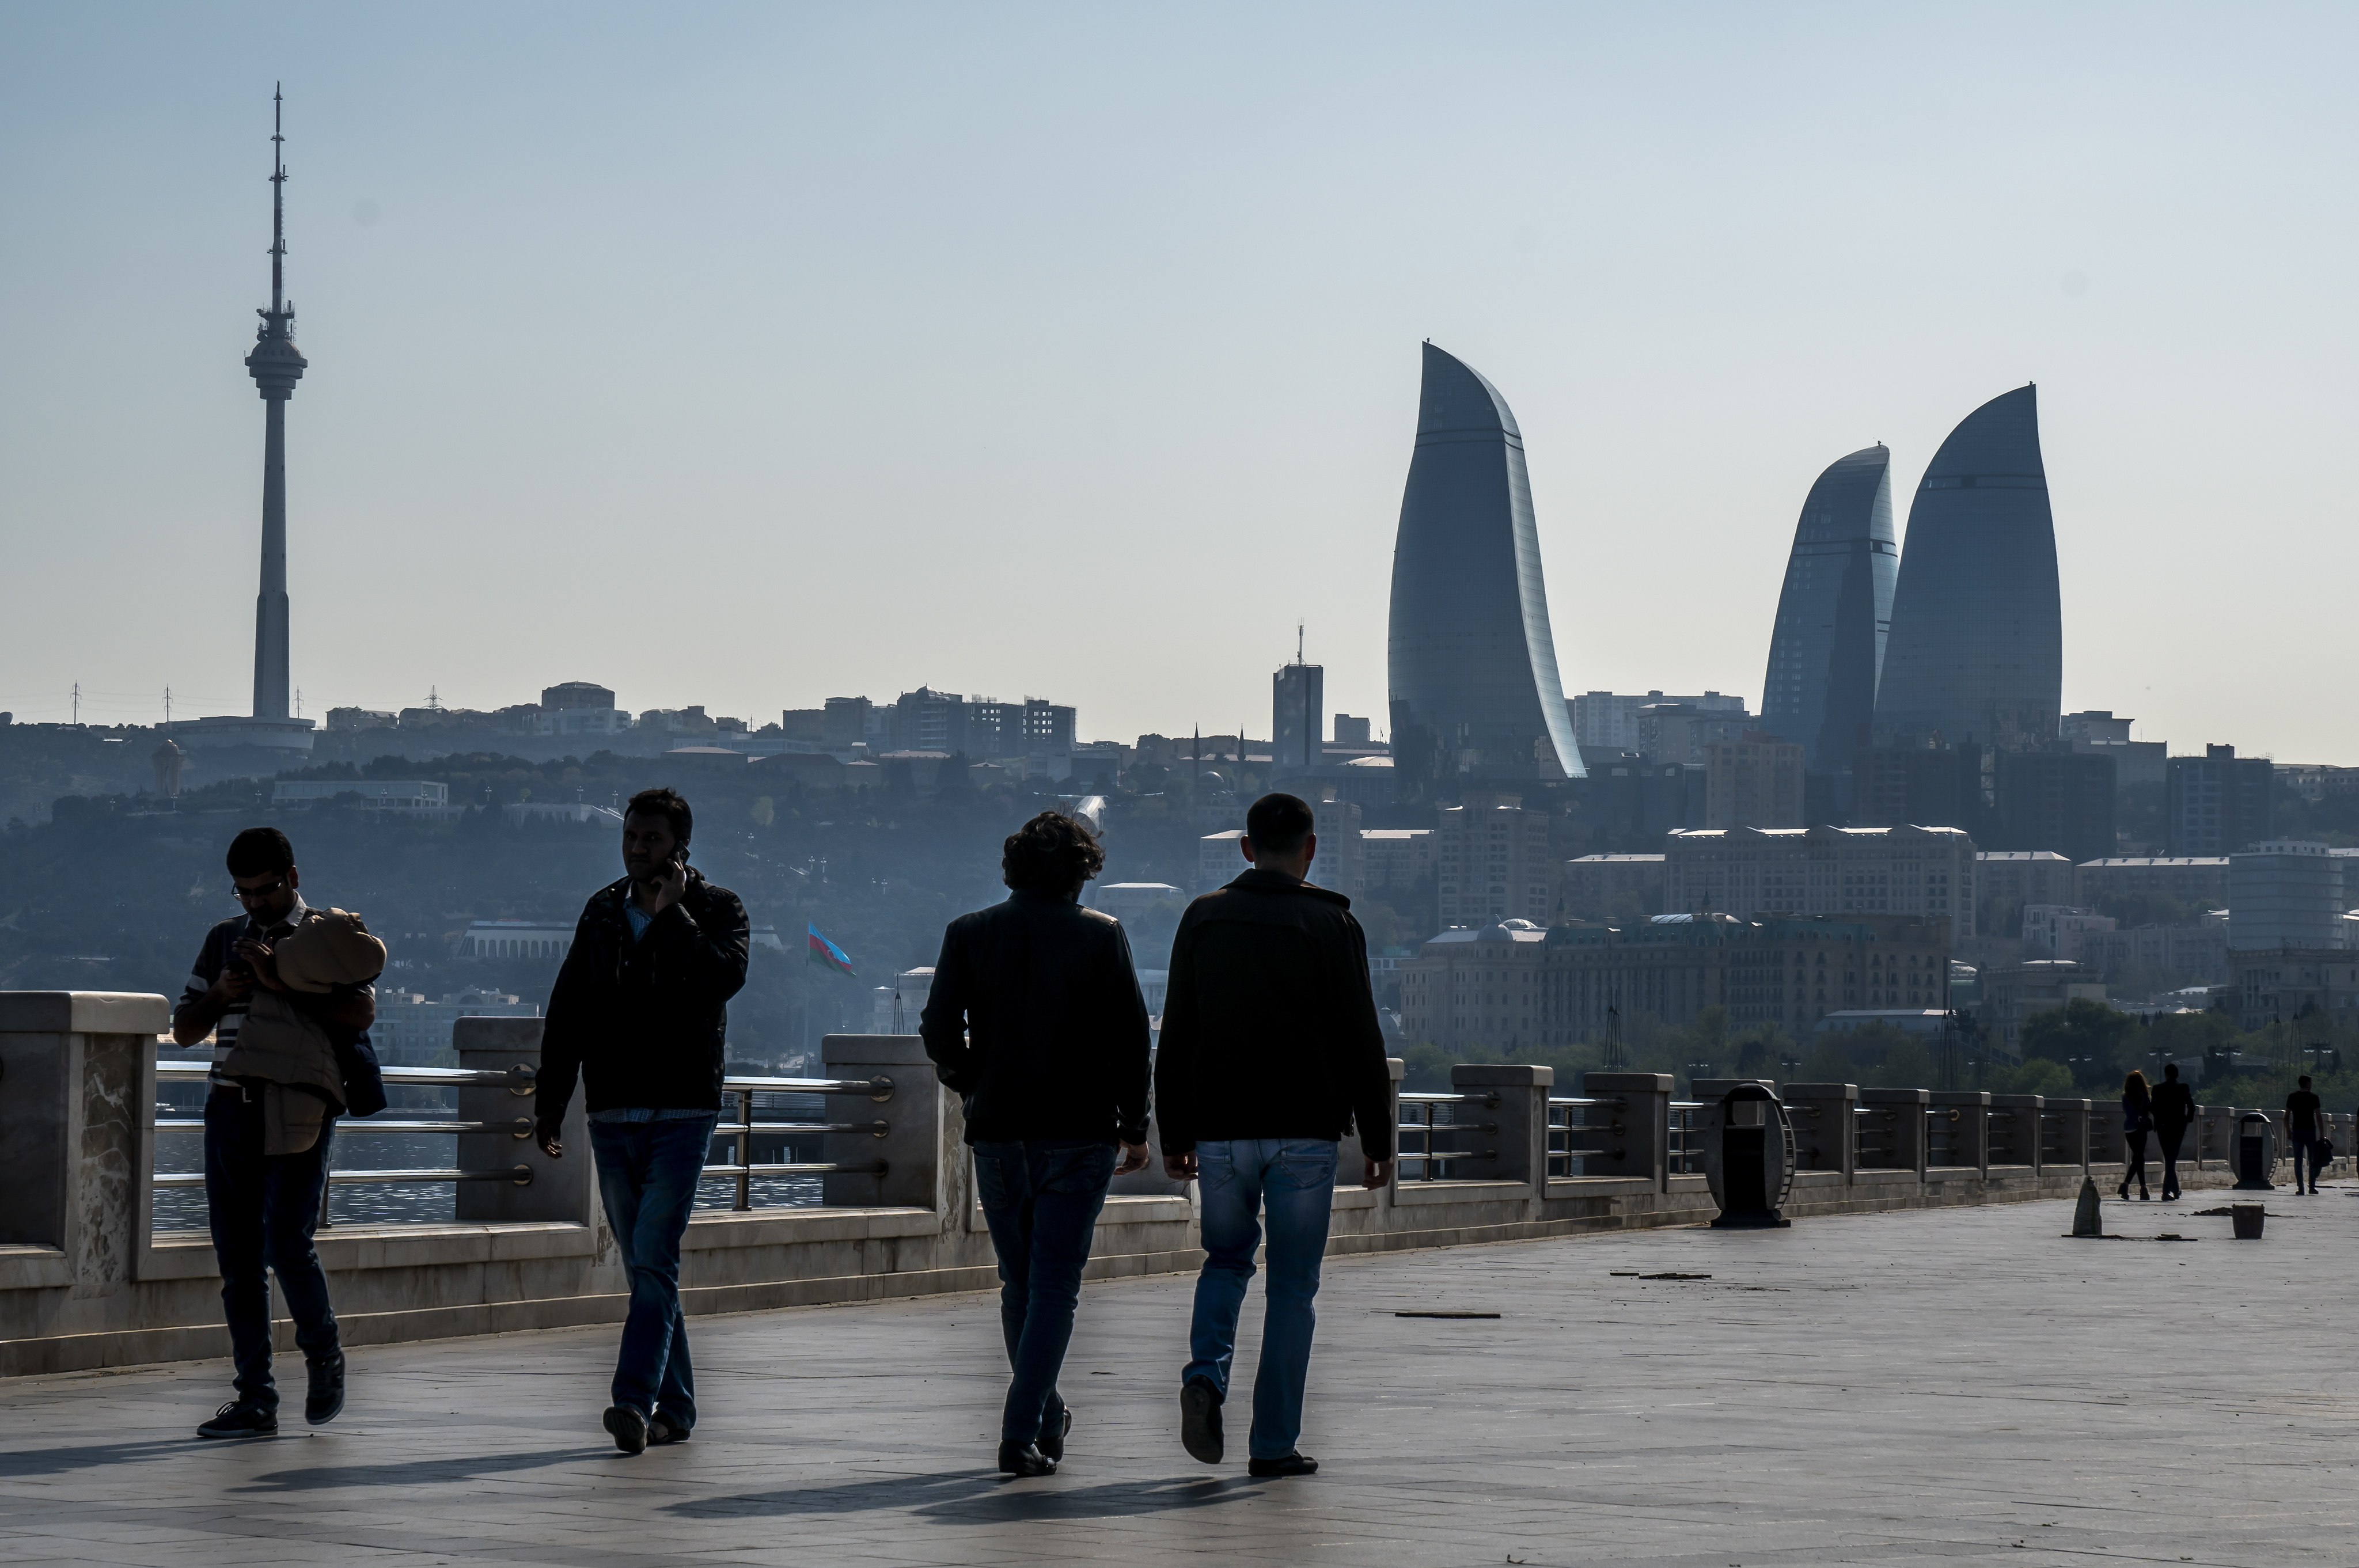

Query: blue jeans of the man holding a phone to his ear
[590,1113,719,1432]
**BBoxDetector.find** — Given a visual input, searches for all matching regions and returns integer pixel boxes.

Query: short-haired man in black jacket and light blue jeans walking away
[1156,795,1394,1476]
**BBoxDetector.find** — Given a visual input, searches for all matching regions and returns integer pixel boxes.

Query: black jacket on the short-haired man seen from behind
[1156,870,1394,1160]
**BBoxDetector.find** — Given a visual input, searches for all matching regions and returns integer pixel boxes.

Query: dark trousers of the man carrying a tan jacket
[205,1087,337,1410]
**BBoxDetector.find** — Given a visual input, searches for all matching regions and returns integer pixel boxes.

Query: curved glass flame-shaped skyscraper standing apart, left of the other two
[1390,344,1583,778]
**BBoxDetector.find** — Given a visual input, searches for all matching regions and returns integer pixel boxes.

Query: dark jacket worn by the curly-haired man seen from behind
[917,889,1147,1144]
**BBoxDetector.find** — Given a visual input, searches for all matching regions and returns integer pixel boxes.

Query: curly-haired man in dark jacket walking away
[917,811,1147,1476]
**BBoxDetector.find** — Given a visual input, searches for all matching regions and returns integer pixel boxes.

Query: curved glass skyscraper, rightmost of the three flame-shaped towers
[1875,387,2064,750]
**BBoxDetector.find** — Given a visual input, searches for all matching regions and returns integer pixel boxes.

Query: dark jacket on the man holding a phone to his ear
[533,868,745,1122]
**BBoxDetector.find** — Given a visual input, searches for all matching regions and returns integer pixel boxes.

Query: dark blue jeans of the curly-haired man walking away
[974,1141,1113,1443]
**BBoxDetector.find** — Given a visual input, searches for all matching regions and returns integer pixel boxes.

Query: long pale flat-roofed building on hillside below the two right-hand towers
[1663,827,1974,941]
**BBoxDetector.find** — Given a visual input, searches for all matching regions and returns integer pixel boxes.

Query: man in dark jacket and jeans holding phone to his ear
[533,790,745,1455]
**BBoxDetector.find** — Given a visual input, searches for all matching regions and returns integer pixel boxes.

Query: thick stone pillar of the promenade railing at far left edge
[0,990,172,1297]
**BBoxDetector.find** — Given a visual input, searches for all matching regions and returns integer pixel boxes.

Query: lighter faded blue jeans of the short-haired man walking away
[1180,1139,1335,1460]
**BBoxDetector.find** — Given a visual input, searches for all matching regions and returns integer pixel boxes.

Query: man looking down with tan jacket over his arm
[172,827,385,1438]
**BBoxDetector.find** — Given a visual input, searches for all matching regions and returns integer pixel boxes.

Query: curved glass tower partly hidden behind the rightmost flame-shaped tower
[1762,443,1899,773]
